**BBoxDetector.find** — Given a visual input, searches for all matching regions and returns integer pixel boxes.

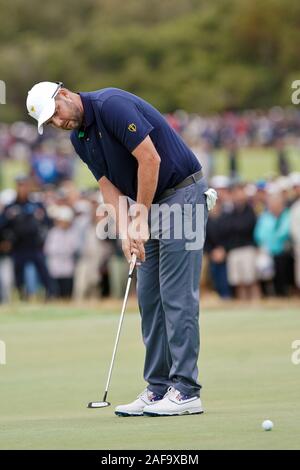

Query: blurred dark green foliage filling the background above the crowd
[0,0,300,120]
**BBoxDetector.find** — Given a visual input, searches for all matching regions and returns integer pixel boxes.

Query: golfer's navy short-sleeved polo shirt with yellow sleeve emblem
[71,88,201,201]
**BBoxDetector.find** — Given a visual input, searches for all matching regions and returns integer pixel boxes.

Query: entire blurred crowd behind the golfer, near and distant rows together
[0,107,300,302]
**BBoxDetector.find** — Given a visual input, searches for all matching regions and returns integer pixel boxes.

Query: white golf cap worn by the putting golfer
[26,82,63,134]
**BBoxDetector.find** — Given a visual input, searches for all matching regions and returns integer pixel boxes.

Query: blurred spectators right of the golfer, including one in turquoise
[205,173,300,299]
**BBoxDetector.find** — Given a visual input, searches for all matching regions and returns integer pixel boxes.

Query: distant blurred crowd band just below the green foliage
[0,106,300,170]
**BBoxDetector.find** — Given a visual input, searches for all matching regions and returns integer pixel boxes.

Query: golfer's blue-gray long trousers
[137,178,208,396]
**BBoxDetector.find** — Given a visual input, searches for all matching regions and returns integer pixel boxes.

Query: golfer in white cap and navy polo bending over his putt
[27,82,214,416]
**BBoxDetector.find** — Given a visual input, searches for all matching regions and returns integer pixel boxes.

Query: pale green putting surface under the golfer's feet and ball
[0,304,300,449]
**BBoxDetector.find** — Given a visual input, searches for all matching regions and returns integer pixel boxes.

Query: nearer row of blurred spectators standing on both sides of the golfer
[0,173,300,302]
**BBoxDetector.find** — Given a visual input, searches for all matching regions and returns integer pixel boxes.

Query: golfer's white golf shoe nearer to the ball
[143,387,203,416]
